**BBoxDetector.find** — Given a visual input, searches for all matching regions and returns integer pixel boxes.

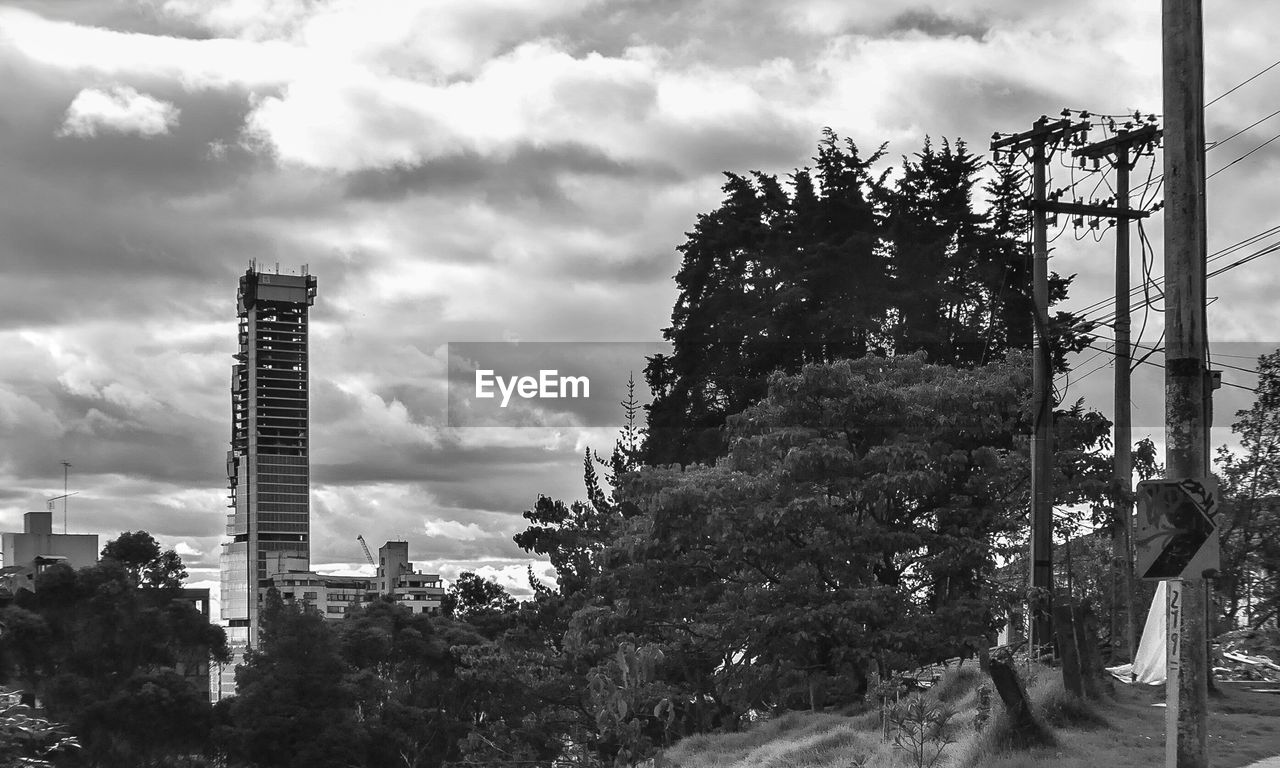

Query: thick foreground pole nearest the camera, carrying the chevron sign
[1161,0,1208,768]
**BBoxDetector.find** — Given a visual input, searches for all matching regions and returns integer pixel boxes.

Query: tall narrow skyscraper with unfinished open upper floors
[211,265,316,699]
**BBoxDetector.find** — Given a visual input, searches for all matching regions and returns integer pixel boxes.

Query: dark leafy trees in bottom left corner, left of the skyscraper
[0,531,228,767]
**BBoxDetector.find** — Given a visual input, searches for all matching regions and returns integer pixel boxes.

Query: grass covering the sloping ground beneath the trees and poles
[664,666,1280,768]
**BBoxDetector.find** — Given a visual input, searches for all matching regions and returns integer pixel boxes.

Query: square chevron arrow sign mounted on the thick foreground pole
[1134,477,1220,580]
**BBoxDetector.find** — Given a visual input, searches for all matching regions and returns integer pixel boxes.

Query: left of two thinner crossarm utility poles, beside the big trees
[991,116,1089,653]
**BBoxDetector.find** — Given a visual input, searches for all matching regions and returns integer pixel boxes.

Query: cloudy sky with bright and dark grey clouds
[0,0,1280,606]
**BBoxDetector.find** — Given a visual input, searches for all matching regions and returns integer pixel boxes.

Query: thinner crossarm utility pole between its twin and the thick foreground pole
[1074,122,1161,660]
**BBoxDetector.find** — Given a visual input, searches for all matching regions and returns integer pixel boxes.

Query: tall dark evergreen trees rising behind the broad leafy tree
[643,131,1083,465]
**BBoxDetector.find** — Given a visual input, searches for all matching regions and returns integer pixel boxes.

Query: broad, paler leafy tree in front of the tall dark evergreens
[571,355,1107,741]
